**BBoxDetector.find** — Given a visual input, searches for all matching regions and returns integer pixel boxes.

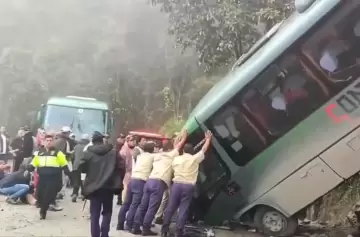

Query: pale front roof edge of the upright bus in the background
[47,97,109,110]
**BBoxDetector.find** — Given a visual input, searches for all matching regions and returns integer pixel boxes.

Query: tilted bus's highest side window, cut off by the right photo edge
[303,0,360,92]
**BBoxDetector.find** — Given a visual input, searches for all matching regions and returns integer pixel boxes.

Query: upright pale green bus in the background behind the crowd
[33,96,113,138]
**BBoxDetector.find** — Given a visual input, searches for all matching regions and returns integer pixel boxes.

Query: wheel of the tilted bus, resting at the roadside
[254,207,298,237]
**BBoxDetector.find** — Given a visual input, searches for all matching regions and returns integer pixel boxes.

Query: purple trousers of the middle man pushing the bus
[134,179,167,231]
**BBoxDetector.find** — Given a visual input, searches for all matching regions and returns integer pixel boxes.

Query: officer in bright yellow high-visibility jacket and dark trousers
[28,135,70,220]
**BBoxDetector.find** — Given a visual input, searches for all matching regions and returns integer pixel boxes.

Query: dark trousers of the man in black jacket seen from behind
[90,190,114,237]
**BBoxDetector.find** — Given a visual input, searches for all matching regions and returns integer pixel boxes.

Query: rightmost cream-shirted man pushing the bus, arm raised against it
[161,131,212,237]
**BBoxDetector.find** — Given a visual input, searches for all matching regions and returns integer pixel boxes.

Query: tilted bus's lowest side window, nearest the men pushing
[207,104,266,166]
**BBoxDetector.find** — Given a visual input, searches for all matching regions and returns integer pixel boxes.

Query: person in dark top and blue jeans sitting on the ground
[0,165,30,204]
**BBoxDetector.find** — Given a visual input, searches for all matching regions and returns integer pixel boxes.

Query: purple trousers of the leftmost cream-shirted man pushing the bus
[118,179,145,229]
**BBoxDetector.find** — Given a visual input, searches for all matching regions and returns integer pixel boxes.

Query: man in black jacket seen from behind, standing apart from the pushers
[79,132,125,237]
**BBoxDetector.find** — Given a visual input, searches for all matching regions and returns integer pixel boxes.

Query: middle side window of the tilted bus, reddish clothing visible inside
[242,55,327,139]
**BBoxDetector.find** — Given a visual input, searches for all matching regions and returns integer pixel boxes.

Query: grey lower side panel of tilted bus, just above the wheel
[256,157,343,216]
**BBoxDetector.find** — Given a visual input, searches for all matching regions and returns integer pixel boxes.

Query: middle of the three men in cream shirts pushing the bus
[134,132,187,236]
